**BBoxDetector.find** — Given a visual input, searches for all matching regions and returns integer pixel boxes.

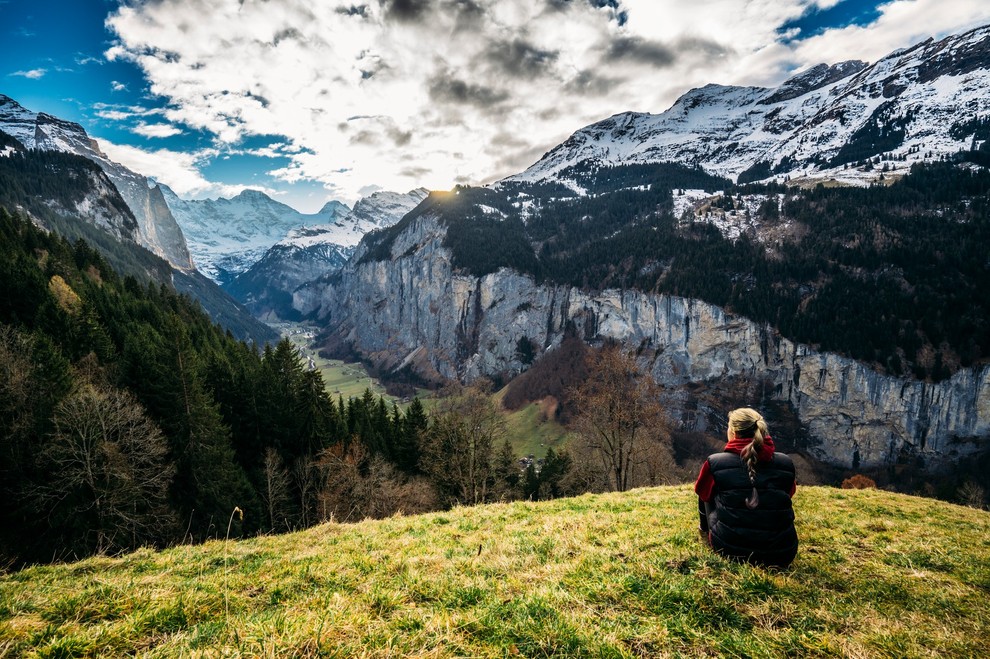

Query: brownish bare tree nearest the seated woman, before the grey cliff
[571,345,673,492]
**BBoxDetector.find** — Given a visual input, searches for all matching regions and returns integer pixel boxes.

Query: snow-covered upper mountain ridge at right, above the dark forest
[507,26,990,184]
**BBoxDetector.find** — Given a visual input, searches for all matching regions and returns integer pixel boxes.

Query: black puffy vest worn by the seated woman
[707,453,798,567]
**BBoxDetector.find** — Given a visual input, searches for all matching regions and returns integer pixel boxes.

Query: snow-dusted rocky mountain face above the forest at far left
[0,94,193,270]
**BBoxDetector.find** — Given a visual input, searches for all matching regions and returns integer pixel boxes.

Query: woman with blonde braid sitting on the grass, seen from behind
[694,407,798,567]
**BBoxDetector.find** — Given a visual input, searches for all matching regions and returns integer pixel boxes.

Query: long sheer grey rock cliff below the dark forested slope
[293,215,990,467]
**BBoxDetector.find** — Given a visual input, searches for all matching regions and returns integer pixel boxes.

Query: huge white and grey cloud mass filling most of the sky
[106,0,990,200]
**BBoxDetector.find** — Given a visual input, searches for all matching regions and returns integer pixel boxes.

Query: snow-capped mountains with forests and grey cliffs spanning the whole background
[0,21,990,500]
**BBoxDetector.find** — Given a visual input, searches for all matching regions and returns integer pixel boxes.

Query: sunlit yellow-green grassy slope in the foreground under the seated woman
[0,486,990,657]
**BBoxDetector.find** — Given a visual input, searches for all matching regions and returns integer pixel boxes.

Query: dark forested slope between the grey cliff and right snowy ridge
[364,159,990,381]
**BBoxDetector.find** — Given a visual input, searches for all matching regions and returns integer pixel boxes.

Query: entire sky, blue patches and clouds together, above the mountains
[0,0,990,212]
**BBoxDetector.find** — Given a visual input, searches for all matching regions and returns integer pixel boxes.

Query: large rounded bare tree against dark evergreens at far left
[39,385,175,551]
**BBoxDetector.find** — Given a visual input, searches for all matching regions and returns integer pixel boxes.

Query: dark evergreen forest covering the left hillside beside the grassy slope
[0,208,440,565]
